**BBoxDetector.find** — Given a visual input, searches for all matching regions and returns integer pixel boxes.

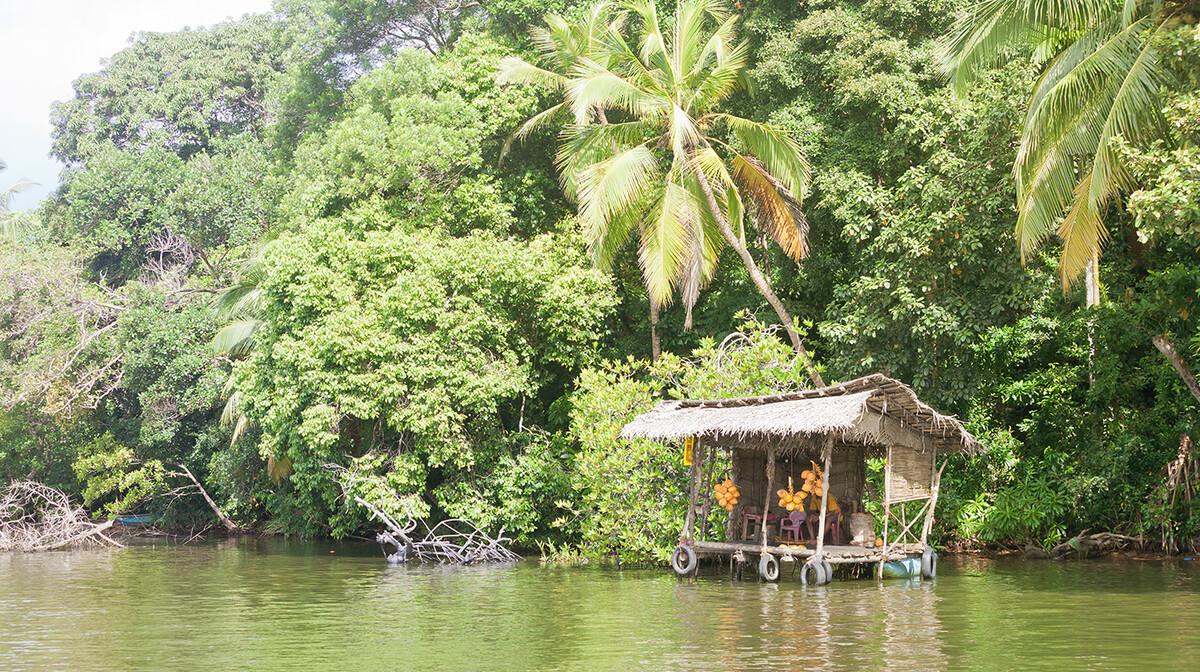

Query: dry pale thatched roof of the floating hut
[620,373,980,454]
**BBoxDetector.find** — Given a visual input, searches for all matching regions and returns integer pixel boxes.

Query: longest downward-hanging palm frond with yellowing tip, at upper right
[1014,8,1169,289]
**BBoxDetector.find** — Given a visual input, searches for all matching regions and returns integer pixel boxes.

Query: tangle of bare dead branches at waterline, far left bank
[0,481,121,552]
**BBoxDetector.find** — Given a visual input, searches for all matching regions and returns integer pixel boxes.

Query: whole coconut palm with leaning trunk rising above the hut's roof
[499,0,824,386]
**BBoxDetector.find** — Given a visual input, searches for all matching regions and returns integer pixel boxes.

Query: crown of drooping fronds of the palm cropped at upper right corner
[943,0,1194,295]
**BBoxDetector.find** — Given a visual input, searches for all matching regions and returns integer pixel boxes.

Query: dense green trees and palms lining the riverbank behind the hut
[0,0,1200,560]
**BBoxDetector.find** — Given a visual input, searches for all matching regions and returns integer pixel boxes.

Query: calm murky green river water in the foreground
[0,538,1200,672]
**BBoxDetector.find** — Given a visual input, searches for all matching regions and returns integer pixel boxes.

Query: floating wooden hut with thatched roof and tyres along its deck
[620,373,980,581]
